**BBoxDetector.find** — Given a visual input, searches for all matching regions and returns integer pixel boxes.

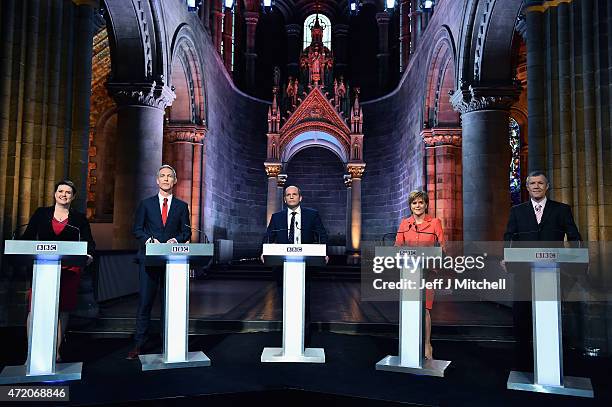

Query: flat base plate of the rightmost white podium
[506,370,594,398]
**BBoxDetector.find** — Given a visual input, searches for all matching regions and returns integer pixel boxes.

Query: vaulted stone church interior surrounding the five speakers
[0,0,612,406]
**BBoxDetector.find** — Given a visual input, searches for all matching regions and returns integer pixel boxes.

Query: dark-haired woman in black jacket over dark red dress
[21,180,96,361]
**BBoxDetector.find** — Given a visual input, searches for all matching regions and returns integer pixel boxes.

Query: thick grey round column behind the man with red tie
[108,82,175,249]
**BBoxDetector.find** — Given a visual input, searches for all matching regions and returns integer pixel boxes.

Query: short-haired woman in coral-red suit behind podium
[395,191,446,359]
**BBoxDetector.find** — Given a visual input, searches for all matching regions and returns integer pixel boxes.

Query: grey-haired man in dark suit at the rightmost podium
[504,171,581,369]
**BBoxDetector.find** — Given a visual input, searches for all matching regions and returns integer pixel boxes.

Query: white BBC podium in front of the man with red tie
[139,243,214,371]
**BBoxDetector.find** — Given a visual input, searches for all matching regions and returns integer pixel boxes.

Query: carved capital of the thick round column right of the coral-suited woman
[450,85,520,114]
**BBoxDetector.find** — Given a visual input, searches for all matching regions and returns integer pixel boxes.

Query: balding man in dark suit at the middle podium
[261,185,329,343]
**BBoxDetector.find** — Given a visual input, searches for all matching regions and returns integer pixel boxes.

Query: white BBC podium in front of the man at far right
[504,248,594,398]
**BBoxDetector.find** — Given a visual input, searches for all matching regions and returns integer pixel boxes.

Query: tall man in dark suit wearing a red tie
[127,165,191,359]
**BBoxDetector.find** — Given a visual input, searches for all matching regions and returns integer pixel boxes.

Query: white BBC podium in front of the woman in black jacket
[0,240,87,384]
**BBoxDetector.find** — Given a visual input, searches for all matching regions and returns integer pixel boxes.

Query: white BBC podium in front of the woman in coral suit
[375,247,451,377]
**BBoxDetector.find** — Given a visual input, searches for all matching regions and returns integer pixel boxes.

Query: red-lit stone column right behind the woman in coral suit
[421,127,463,241]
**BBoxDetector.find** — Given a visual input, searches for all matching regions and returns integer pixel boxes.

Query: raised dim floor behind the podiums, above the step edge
[83,277,512,340]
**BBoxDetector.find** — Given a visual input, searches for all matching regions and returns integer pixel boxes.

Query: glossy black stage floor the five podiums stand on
[0,328,612,406]
